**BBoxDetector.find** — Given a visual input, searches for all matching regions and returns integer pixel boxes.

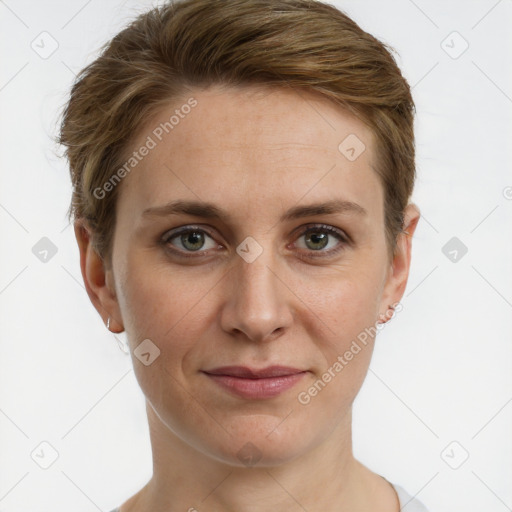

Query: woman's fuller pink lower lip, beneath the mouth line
[206,372,306,399]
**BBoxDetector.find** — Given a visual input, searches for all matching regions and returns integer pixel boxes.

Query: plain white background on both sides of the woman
[0,0,512,512]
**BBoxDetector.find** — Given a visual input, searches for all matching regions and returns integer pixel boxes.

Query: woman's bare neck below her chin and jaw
[121,404,398,512]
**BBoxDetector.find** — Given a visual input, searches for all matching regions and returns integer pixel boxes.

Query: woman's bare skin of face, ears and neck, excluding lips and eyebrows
[75,82,420,512]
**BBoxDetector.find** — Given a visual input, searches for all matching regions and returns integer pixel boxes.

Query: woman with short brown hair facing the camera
[60,0,425,512]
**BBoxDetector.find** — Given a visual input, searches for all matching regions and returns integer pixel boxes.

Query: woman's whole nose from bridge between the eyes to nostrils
[223,237,291,341]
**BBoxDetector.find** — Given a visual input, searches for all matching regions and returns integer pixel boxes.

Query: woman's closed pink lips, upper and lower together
[203,366,307,400]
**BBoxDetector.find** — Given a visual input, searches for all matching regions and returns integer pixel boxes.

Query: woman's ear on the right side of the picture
[380,203,420,323]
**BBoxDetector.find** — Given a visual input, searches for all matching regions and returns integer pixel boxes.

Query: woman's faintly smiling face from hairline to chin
[79,86,416,465]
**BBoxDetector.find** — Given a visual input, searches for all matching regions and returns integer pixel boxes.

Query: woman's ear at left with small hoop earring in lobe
[74,219,124,333]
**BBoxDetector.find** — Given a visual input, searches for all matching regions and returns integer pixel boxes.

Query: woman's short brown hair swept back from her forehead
[58,0,416,264]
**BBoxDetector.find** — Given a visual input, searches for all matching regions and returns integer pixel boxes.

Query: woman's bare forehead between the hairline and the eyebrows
[114,86,382,225]
